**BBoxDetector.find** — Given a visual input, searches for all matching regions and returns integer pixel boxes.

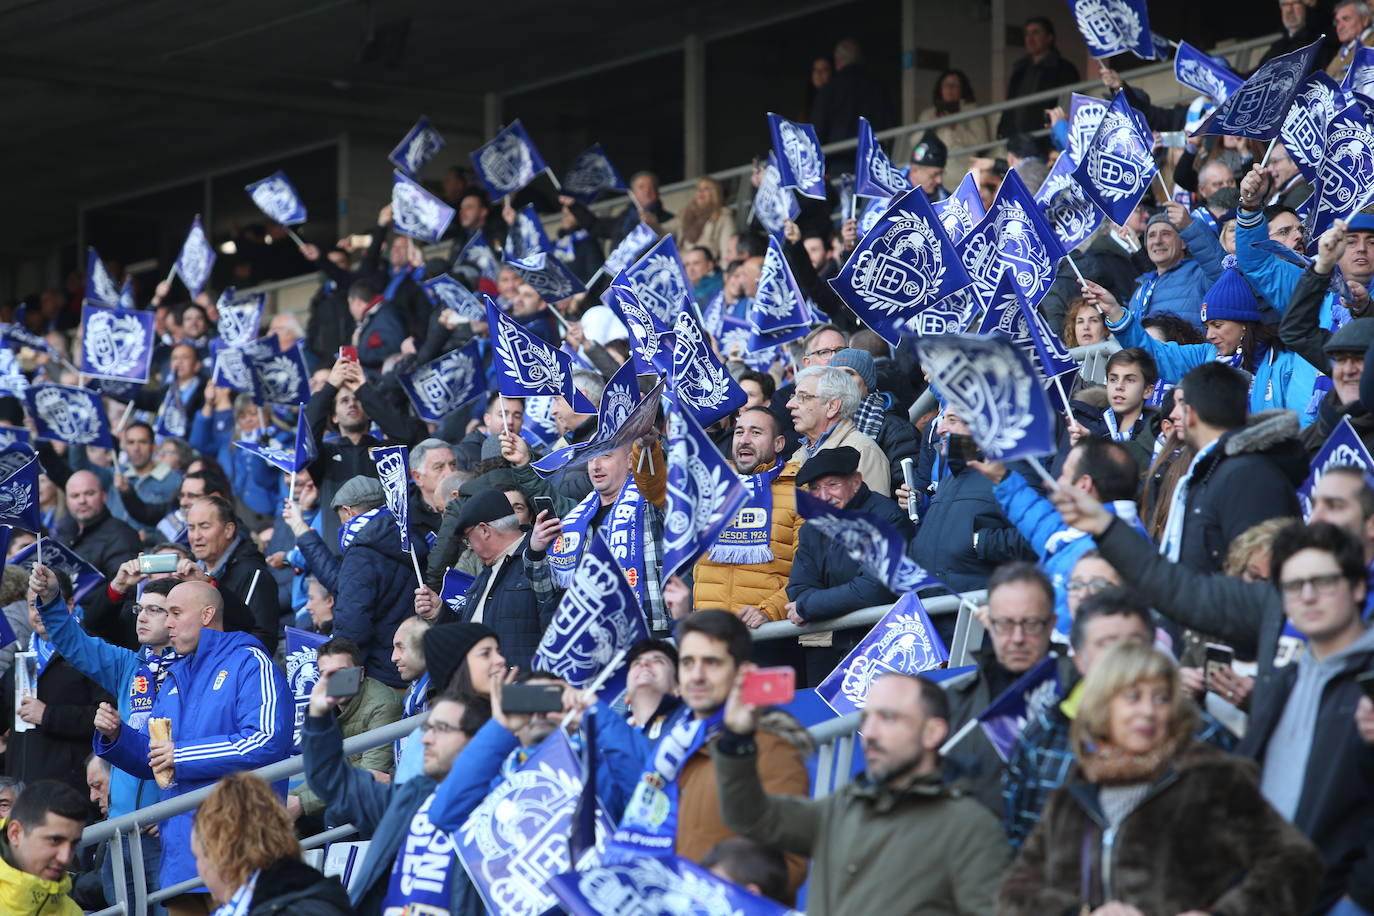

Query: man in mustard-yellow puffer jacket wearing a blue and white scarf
[692,407,802,628]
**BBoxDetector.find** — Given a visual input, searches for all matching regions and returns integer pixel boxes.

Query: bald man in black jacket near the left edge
[58,471,142,650]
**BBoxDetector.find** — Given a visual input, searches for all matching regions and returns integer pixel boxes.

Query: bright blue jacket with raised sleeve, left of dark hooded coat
[992,471,1156,634]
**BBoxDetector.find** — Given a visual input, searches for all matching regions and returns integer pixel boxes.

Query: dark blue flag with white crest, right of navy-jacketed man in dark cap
[533,530,649,689]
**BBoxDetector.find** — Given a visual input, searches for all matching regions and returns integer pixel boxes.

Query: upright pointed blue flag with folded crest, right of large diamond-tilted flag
[958,169,1063,311]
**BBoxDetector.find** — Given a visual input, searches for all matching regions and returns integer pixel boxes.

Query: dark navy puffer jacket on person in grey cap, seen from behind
[328,512,429,687]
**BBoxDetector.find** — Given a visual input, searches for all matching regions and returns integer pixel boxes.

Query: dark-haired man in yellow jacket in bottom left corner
[0,779,88,916]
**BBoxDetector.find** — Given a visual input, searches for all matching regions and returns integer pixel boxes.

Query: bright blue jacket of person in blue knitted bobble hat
[1107,304,1322,426]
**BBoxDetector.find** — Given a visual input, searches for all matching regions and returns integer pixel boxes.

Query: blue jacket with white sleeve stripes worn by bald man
[95,629,294,887]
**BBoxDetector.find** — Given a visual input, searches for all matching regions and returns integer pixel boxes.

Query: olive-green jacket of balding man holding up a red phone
[712,735,1010,916]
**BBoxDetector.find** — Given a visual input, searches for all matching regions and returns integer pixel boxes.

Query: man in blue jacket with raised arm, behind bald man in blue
[30,560,176,912]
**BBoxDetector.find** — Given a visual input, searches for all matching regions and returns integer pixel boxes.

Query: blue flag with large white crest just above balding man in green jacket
[816,592,949,715]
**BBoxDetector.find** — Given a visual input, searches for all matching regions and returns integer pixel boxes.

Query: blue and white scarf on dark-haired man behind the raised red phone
[606,706,725,862]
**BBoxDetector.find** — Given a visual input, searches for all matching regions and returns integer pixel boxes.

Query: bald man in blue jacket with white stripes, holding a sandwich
[96,581,293,912]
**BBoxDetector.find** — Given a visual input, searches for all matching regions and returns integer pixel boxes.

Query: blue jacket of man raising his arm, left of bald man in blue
[38,597,158,817]
